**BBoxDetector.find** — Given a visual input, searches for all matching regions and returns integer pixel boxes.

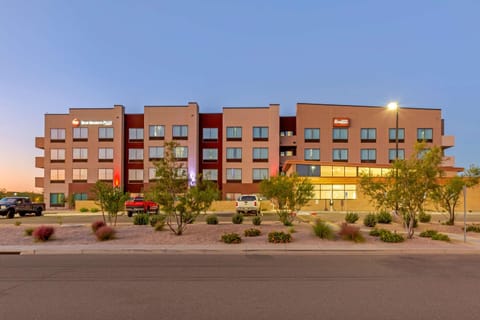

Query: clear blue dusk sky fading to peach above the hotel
[0,0,480,191]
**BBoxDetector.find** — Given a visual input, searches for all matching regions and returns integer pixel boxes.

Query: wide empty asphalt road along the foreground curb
[0,254,480,320]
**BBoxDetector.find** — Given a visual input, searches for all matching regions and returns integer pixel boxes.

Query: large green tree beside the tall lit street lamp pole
[360,143,442,239]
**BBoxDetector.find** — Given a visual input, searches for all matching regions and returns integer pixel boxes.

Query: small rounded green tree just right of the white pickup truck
[260,174,313,226]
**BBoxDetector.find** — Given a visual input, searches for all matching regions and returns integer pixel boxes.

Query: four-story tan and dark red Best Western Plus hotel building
[35,102,460,209]
